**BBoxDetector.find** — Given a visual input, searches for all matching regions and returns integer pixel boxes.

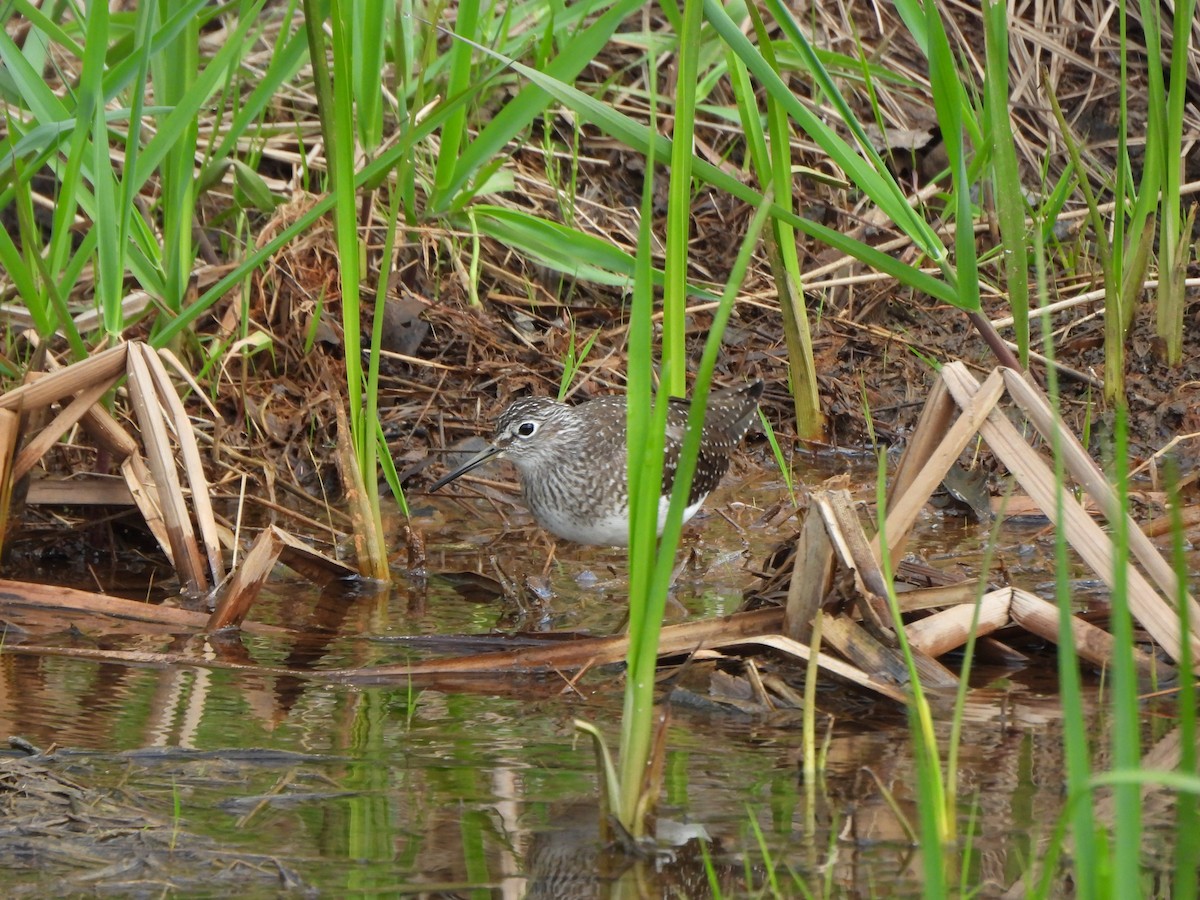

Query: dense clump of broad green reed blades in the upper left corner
[0,0,294,345]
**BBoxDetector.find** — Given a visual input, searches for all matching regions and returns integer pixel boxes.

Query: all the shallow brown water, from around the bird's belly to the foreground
[0,468,1195,898]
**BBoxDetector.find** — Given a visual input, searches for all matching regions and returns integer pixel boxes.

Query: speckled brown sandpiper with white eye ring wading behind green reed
[431,382,762,546]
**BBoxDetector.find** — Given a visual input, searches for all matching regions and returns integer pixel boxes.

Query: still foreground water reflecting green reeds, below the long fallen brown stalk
[0,638,1180,896]
